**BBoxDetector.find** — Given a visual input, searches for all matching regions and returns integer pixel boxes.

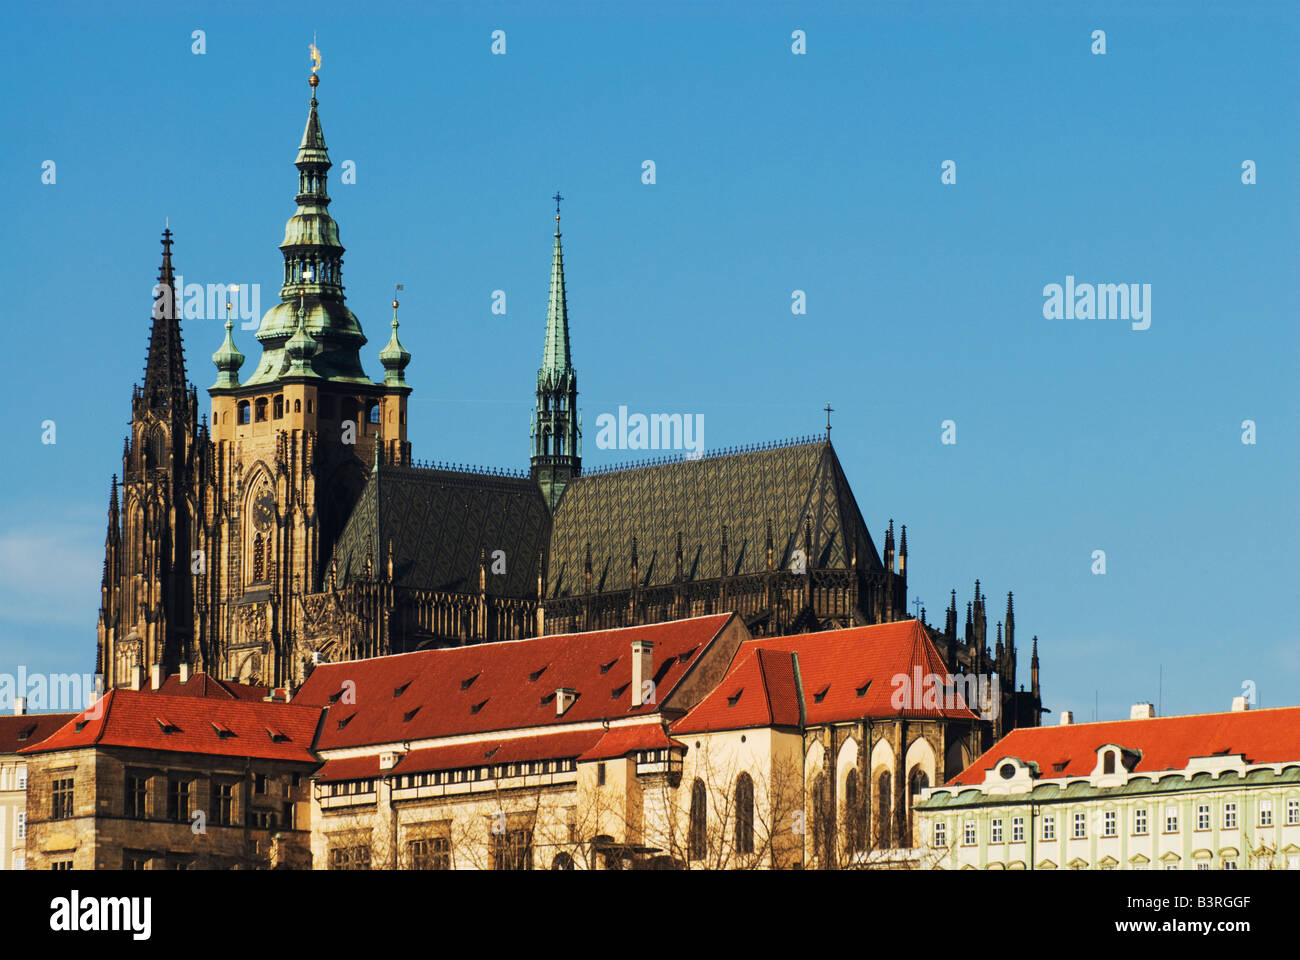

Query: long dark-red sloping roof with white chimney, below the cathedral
[293,614,733,751]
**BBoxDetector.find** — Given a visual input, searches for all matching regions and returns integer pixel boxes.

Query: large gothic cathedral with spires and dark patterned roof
[96,70,1043,735]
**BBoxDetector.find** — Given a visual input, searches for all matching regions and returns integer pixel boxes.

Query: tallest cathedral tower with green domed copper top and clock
[200,72,411,684]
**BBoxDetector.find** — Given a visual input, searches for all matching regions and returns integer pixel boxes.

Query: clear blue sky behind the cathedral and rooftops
[0,3,1300,719]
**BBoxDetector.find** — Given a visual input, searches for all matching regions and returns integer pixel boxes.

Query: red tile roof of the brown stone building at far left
[22,689,321,764]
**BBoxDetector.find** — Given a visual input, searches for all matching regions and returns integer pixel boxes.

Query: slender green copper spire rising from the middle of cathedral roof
[532,200,582,511]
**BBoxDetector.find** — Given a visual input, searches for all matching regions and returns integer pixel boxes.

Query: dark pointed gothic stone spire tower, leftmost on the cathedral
[95,230,209,686]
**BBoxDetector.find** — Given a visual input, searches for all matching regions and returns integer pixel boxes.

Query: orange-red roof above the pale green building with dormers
[949,706,1300,786]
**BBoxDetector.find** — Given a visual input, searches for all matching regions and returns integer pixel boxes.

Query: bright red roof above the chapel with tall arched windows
[672,620,975,734]
